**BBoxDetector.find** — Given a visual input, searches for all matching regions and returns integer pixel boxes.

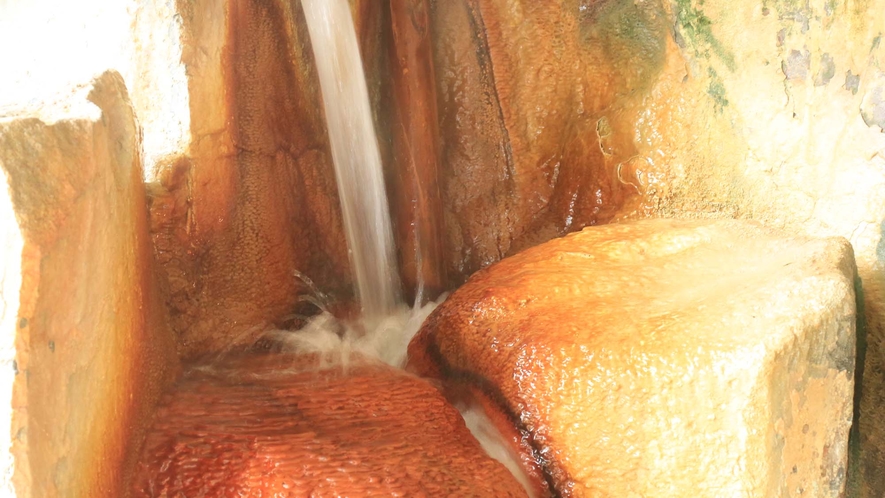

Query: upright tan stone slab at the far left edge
[0,72,177,498]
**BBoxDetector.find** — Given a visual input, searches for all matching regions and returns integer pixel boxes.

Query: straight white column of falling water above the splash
[301,0,401,323]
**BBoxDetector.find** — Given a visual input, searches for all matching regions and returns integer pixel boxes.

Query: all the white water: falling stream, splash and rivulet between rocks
[296,5,533,496]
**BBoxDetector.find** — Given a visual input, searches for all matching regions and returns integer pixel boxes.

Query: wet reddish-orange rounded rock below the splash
[133,354,525,498]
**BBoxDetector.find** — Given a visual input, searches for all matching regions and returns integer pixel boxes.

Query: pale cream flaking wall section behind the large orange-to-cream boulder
[592,0,885,498]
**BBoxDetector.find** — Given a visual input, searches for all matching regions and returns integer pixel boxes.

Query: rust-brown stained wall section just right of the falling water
[431,0,670,285]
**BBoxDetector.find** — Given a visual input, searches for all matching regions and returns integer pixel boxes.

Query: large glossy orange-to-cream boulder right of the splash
[409,220,855,497]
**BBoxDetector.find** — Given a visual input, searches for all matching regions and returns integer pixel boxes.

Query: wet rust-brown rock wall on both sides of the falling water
[150,0,656,358]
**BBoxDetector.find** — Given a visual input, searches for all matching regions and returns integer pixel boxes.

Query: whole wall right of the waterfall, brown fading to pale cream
[431,0,885,498]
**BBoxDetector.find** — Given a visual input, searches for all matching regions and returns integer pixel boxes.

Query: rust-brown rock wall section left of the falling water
[159,0,352,358]
